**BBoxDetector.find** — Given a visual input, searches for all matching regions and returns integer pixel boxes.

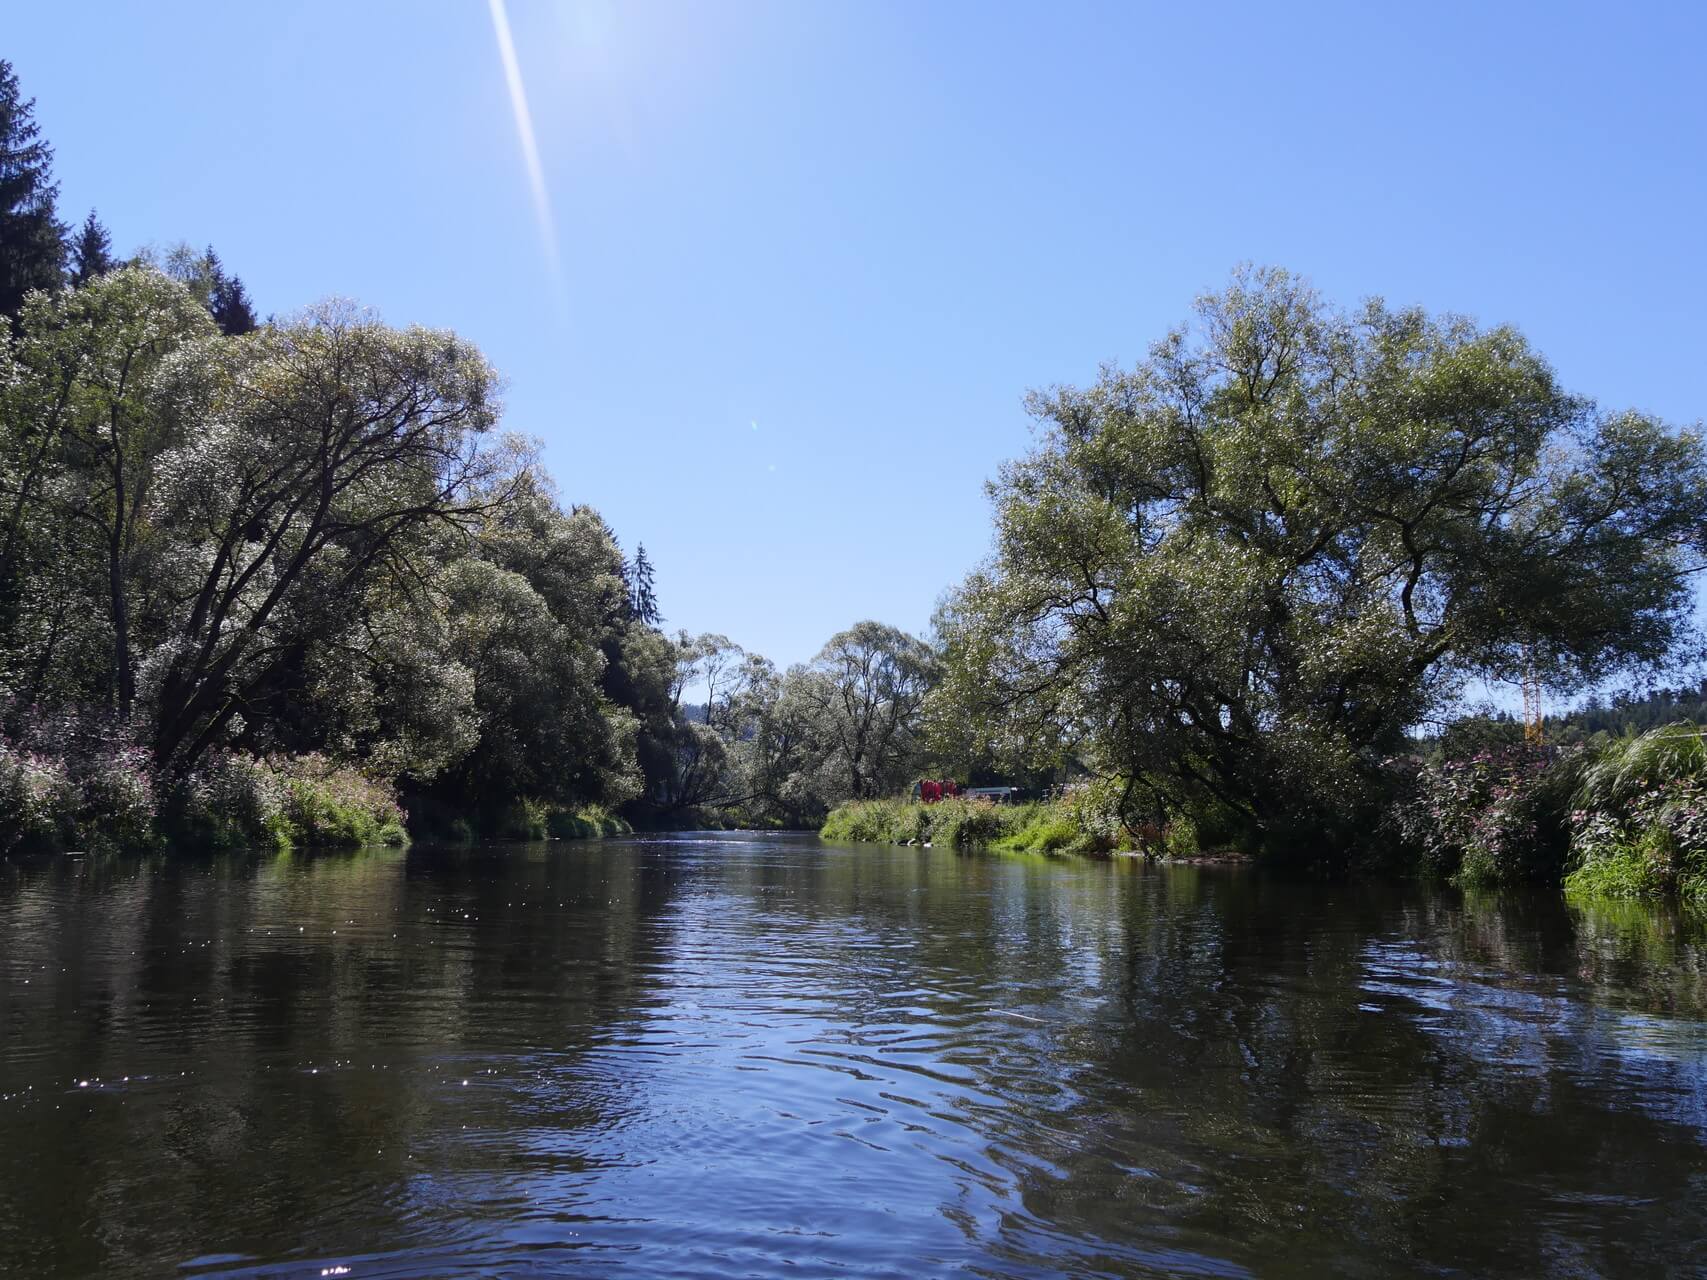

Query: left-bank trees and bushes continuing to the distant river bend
[0,63,932,852]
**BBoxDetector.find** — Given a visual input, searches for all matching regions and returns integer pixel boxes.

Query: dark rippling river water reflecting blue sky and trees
[0,835,1707,1280]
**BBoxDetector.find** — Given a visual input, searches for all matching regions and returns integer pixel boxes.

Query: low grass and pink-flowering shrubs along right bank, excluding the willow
[819,724,1707,906]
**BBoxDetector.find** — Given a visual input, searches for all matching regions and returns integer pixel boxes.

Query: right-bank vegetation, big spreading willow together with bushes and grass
[826,270,1707,896]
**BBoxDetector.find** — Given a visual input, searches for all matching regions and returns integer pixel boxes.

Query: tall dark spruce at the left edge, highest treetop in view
[0,58,65,316]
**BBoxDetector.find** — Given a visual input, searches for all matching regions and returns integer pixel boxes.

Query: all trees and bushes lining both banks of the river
[0,55,1707,896]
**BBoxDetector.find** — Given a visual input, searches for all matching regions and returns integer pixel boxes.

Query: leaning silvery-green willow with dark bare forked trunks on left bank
[138,304,522,771]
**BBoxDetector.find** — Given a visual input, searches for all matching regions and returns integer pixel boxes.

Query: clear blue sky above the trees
[0,0,1707,662]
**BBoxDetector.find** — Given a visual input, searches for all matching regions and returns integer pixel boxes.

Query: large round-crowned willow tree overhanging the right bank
[935,270,1707,847]
